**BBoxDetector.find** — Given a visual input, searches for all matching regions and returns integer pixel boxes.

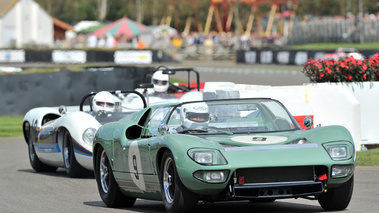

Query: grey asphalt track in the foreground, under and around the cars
[0,137,379,213]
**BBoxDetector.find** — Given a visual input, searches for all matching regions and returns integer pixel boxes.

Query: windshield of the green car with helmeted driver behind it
[167,99,300,134]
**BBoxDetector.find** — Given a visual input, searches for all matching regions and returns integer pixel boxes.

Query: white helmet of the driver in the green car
[180,103,209,129]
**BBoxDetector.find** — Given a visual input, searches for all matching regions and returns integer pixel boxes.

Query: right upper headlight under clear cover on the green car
[323,141,354,161]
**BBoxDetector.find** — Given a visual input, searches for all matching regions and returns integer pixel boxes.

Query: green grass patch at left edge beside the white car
[0,116,24,138]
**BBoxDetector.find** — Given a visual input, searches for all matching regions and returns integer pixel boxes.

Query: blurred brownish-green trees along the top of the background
[35,0,379,31]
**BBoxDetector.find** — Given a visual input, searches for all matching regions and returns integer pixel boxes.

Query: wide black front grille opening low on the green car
[230,166,327,199]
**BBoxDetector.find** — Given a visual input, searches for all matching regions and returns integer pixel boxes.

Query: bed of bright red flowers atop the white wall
[302,52,379,82]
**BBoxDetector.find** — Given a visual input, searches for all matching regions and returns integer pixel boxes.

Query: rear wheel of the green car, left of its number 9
[94,147,136,208]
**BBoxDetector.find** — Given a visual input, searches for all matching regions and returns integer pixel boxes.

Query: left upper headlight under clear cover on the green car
[188,148,227,166]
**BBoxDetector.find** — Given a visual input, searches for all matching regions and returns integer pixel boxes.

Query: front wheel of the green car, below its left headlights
[159,150,198,213]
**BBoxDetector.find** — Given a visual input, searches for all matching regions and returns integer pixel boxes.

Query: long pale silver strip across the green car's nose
[225,144,318,152]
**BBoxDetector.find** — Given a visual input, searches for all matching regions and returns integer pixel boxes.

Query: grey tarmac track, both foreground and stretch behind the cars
[0,61,372,213]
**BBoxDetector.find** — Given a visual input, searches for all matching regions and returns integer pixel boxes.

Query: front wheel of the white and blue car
[62,131,93,178]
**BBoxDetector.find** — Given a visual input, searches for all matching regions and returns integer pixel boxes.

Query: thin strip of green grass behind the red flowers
[288,42,379,50]
